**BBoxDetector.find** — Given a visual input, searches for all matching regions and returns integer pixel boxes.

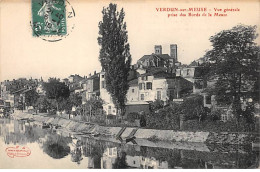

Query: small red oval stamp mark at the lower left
[5,146,31,158]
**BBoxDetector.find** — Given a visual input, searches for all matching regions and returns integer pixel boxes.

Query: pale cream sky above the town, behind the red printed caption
[0,0,260,81]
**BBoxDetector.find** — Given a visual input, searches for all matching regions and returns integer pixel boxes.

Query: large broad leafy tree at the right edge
[205,25,259,123]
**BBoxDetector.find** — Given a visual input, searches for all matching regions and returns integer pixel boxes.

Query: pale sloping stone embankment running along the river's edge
[11,111,259,145]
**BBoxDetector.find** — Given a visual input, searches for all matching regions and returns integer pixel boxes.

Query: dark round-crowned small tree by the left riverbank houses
[43,78,70,110]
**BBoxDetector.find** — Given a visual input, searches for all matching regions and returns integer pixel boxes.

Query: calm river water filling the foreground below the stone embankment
[0,119,259,169]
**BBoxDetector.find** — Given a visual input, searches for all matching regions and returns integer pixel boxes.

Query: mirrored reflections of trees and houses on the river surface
[0,120,259,169]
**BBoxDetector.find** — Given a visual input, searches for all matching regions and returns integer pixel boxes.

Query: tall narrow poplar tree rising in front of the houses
[98,3,132,114]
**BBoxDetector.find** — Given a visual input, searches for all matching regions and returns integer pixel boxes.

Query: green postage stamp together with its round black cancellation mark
[31,0,76,42]
